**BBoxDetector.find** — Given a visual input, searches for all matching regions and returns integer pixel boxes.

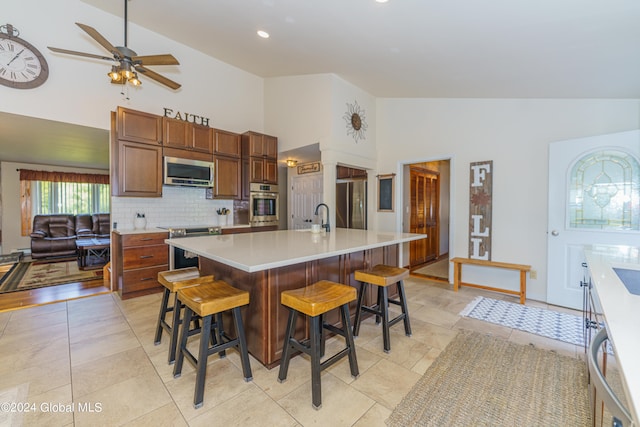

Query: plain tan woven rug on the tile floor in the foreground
[386,331,591,427]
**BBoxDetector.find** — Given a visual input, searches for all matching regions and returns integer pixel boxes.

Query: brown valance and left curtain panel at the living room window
[20,169,109,236]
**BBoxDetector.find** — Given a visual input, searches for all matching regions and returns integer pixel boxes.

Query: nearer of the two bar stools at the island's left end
[173,279,253,409]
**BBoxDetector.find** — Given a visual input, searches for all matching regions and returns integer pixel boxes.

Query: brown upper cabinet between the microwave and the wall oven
[207,129,242,199]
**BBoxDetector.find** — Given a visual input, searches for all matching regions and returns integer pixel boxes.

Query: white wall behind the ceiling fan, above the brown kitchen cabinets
[0,0,264,132]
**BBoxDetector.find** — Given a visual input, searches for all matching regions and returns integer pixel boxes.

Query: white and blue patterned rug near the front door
[460,297,584,345]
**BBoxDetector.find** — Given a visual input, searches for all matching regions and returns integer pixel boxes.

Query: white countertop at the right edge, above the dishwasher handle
[585,245,640,424]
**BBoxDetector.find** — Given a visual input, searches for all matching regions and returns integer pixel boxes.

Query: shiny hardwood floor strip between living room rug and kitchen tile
[0,280,111,312]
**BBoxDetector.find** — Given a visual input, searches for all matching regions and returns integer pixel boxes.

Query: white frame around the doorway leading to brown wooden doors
[394,154,456,283]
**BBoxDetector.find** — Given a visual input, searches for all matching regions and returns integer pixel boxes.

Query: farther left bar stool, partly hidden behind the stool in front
[154,267,213,364]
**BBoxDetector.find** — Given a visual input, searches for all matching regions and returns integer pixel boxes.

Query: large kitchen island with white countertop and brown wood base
[165,228,426,368]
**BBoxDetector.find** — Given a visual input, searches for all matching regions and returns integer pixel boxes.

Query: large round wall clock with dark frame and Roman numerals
[0,24,49,89]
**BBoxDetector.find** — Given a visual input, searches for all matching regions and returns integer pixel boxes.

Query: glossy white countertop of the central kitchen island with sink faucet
[165,228,427,273]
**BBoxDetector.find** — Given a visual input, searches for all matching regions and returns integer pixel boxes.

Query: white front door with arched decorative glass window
[547,131,640,309]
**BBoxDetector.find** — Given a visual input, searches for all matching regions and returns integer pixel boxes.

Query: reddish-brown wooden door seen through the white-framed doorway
[409,167,440,267]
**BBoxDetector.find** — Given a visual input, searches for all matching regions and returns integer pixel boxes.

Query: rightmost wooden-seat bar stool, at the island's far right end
[353,264,411,353]
